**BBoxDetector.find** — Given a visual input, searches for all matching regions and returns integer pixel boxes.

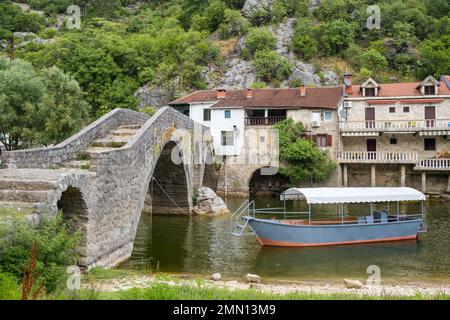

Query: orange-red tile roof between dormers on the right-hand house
[350,81,450,97]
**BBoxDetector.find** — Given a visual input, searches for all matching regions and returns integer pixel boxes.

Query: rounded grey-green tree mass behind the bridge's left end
[0,59,89,150]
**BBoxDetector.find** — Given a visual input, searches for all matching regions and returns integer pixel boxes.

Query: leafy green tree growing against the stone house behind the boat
[275,118,336,185]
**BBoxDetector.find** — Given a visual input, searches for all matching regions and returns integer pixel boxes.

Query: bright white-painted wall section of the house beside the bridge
[189,103,245,156]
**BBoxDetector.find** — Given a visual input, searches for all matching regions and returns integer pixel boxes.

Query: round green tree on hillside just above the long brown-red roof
[253,50,293,83]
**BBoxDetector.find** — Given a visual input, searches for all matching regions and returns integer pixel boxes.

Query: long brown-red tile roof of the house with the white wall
[169,87,343,109]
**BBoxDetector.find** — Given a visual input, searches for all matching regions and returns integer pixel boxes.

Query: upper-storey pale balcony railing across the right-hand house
[340,119,450,131]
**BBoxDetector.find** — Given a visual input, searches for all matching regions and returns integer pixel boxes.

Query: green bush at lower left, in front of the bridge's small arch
[0,214,79,291]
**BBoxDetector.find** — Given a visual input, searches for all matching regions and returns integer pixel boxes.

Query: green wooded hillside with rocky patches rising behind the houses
[0,0,450,117]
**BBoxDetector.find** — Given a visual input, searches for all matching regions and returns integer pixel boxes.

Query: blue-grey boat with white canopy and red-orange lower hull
[234,188,426,247]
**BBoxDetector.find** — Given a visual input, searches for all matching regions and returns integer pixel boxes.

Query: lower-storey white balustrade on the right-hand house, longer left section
[339,151,419,164]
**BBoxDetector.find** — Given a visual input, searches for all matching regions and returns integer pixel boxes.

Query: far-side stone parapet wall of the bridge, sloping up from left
[2,109,149,168]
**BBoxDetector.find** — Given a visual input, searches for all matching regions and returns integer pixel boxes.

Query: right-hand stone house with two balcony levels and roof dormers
[338,74,450,193]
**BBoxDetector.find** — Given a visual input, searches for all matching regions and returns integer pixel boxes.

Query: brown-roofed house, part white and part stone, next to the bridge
[169,86,343,196]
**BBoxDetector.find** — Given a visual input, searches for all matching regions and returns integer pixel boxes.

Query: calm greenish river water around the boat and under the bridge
[121,197,450,283]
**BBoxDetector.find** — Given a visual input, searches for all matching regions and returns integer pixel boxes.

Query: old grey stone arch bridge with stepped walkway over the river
[0,107,217,267]
